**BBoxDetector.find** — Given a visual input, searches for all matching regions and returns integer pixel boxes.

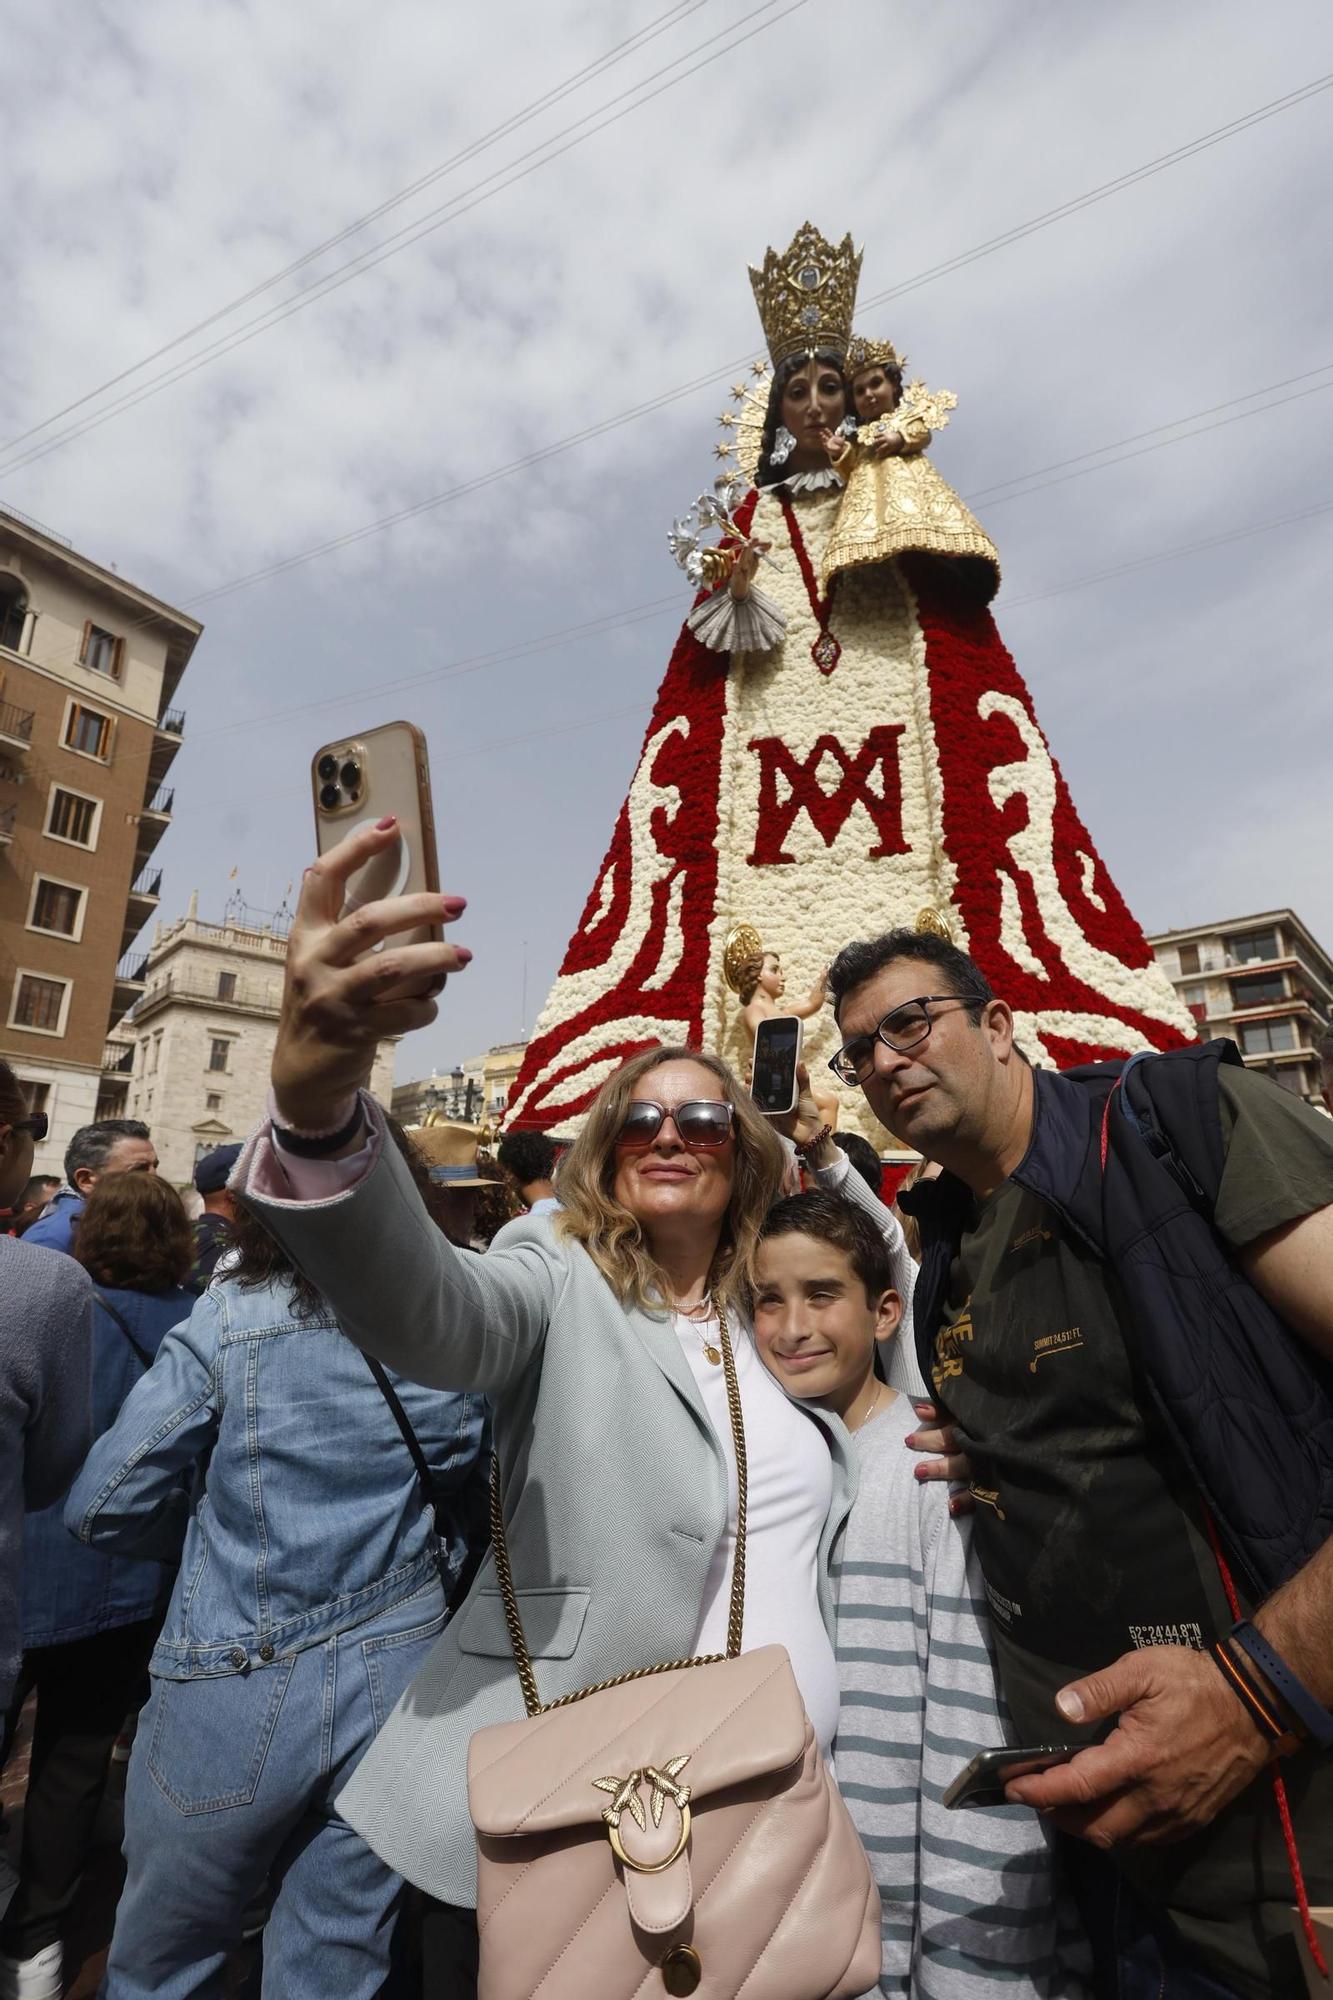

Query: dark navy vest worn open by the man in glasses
[905,1042,1333,1598]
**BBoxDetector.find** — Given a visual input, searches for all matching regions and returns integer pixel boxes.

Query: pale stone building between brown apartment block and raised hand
[102,898,396,1188]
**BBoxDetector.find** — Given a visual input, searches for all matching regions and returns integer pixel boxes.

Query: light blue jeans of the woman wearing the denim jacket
[102,1582,444,2000]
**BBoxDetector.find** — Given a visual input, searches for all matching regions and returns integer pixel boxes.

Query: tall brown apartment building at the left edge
[0,510,202,1172]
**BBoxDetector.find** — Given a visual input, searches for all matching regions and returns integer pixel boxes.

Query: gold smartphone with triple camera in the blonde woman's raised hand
[310,722,442,956]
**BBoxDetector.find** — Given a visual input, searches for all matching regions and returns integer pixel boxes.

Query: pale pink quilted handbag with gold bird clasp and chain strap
[468,1308,881,2000]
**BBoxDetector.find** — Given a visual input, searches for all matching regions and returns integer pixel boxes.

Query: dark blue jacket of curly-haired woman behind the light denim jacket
[22,1284,194,1650]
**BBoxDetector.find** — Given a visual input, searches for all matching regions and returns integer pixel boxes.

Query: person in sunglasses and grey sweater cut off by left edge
[0,1060,92,1752]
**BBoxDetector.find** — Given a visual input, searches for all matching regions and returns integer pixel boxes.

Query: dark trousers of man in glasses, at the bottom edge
[1061,1840,1237,2000]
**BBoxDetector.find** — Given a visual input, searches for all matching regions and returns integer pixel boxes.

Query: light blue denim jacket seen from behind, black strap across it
[64,1276,488,1680]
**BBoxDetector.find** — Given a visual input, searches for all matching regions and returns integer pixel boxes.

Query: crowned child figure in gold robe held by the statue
[823,336,999,604]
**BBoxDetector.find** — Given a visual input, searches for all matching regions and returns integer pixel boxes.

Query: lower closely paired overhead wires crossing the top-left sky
[0,0,807,476]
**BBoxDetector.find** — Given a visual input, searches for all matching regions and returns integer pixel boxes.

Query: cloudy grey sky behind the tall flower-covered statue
[0,0,1333,1078]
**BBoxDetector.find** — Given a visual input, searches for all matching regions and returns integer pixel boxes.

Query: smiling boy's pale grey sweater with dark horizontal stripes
[835,1396,1085,2000]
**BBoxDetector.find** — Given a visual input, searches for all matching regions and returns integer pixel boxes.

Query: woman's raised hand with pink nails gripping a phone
[272,818,472,1132]
